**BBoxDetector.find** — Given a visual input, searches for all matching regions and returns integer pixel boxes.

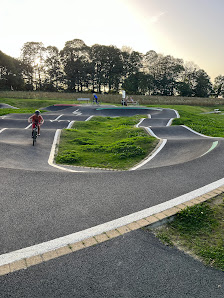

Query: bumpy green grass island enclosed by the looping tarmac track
[55,116,158,170]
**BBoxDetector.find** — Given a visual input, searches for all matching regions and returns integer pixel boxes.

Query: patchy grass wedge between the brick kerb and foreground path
[150,199,224,271]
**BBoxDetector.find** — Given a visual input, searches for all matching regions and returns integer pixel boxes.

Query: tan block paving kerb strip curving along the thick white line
[0,186,224,275]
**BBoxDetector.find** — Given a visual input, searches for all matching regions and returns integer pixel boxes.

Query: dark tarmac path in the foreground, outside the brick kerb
[0,230,224,298]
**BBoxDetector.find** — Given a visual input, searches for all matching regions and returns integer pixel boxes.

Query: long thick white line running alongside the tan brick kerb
[0,178,224,266]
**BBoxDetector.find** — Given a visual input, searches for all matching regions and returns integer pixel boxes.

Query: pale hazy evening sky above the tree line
[0,0,224,81]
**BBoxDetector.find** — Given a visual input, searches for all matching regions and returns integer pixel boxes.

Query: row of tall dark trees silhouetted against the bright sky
[0,39,224,97]
